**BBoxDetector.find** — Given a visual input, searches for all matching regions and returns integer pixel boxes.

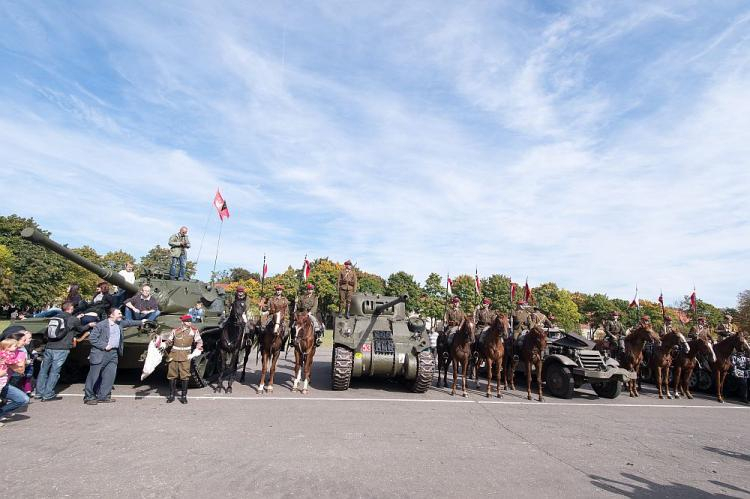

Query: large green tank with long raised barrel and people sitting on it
[16,227,224,386]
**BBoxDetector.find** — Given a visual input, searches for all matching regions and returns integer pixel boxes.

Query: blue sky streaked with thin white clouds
[0,0,750,306]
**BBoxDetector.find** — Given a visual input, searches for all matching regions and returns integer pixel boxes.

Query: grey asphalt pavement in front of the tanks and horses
[5,349,750,498]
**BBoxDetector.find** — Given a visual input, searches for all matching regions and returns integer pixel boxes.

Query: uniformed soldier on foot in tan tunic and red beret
[156,314,203,404]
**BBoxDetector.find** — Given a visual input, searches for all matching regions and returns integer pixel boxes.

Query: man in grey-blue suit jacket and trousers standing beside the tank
[83,307,146,405]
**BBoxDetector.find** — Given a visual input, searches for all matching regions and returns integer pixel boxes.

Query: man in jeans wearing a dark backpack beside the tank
[36,301,94,402]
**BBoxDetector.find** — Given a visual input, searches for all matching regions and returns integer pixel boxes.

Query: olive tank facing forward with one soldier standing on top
[331,293,435,393]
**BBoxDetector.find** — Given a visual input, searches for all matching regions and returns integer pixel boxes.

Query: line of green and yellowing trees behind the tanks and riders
[0,215,750,331]
